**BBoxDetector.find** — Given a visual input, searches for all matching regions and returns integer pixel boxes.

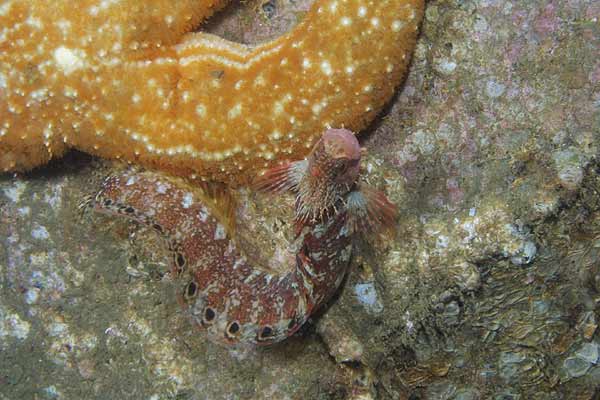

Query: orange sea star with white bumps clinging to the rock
[0,0,423,183]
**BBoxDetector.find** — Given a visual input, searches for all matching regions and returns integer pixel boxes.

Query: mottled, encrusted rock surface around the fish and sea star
[0,0,600,400]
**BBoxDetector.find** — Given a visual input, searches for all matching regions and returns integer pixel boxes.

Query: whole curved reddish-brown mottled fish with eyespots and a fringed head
[92,129,395,344]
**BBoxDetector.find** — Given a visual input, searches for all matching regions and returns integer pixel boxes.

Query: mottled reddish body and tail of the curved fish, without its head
[93,172,351,344]
